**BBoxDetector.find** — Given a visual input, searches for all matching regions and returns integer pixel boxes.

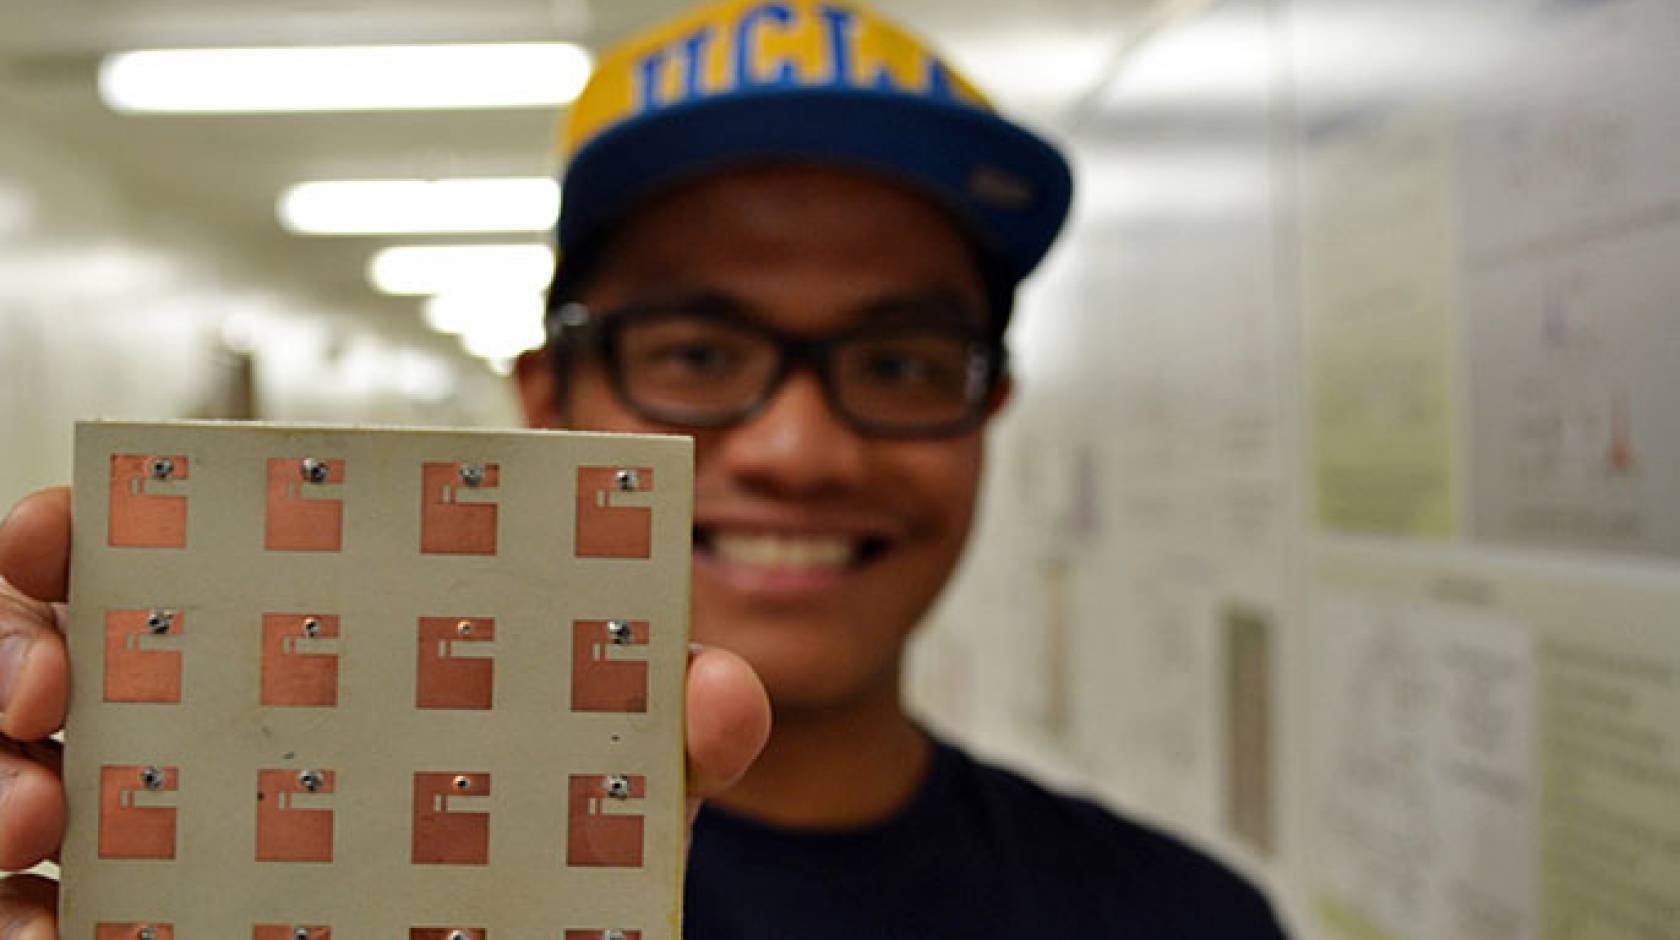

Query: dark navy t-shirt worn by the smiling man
[684,742,1284,940]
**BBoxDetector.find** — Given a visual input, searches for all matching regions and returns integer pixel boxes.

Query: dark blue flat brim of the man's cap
[559,87,1074,280]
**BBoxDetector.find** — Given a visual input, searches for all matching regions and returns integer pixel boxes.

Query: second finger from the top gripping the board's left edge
[0,581,71,740]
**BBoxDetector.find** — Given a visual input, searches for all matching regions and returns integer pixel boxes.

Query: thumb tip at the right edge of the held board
[687,650,769,821]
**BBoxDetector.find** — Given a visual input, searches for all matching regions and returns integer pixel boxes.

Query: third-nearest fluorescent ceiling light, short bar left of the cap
[368,245,554,295]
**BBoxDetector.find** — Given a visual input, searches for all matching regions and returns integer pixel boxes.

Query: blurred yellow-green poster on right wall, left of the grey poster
[1300,111,1458,539]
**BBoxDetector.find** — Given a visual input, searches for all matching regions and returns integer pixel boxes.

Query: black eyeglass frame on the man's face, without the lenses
[548,302,1008,440]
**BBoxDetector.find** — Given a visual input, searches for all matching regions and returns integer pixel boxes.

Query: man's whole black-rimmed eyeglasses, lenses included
[551,304,1005,438]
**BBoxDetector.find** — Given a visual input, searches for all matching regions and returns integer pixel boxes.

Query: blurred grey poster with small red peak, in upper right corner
[1463,0,1680,556]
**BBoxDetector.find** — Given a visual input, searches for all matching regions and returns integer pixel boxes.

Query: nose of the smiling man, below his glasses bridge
[717,369,869,497]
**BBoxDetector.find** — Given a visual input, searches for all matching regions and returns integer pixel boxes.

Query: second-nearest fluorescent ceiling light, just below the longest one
[277,176,559,235]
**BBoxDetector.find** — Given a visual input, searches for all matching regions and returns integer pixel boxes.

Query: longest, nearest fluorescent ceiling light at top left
[99,42,593,114]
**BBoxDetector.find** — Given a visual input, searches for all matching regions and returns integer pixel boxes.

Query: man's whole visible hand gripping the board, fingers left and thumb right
[0,488,769,940]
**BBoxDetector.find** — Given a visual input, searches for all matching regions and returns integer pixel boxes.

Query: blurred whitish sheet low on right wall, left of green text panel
[1312,589,1536,940]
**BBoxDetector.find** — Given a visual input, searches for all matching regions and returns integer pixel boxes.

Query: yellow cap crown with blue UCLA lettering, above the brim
[559,0,993,156]
